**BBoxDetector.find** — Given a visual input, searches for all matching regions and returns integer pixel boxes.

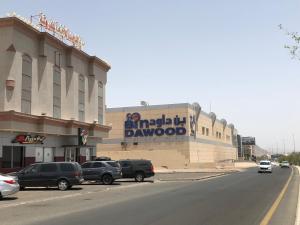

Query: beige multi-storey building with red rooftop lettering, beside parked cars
[0,16,110,172]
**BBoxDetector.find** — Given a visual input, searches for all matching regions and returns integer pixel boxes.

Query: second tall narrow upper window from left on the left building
[53,66,61,119]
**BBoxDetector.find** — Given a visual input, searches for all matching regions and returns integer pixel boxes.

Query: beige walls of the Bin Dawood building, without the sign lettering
[97,104,237,168]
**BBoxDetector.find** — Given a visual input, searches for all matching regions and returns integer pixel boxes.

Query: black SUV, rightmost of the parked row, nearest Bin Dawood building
[118,159,155,182]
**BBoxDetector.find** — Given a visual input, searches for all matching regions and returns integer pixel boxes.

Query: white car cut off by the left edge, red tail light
[0,174,20,199]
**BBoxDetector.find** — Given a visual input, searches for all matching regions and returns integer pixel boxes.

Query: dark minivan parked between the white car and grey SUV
[10,162,83,191]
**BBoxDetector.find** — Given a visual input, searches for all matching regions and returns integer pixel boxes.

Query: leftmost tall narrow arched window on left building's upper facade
[21,55,32,114]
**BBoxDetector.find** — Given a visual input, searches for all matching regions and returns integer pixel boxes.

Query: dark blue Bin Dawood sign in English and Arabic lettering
[124,112,186,138]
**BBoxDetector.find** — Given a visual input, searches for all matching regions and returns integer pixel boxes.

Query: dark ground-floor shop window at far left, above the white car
[2,146,24,168]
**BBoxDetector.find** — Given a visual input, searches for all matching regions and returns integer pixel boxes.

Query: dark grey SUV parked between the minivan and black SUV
[81,161,122,185]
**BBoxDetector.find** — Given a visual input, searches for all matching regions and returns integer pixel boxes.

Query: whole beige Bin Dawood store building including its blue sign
[97,103,237,168]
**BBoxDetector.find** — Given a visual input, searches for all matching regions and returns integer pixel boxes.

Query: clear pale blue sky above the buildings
[0,0,300,151]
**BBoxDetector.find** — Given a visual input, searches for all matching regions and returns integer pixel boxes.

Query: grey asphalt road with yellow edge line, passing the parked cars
[0,168,298,225]
